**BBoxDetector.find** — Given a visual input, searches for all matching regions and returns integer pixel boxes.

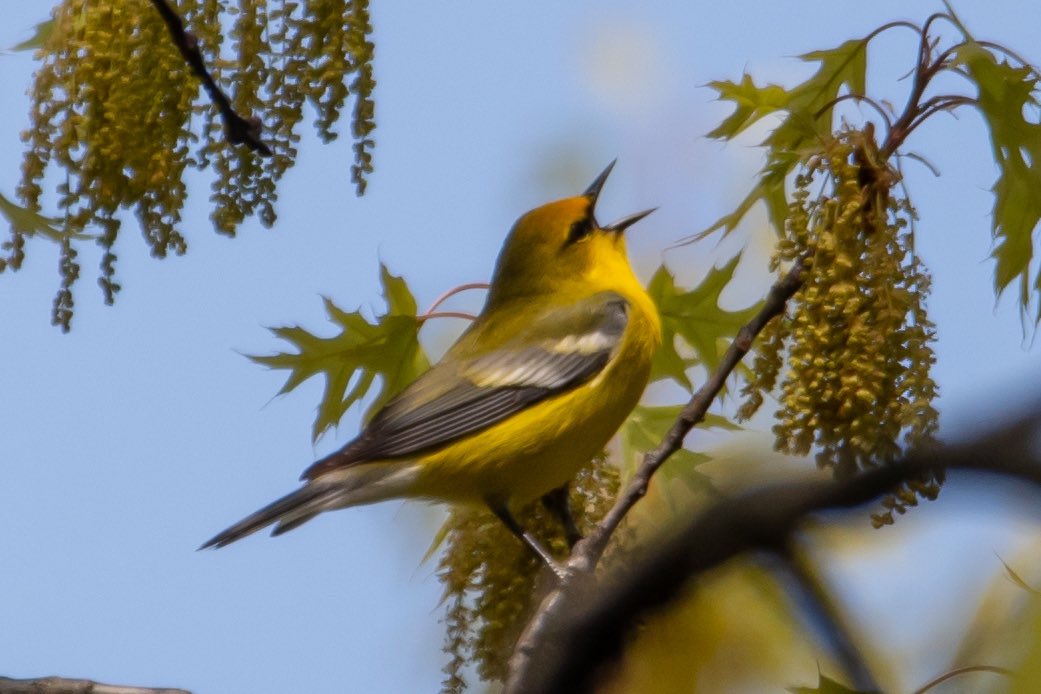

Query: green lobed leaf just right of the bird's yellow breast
[648,254,761,391]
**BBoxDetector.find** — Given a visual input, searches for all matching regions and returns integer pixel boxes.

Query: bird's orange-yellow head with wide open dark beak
[489,161,654,302]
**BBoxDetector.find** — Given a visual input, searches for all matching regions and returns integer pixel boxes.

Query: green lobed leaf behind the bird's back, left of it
[249,263,430,440]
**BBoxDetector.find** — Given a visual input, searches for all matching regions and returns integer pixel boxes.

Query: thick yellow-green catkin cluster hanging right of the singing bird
[741,129,942,525]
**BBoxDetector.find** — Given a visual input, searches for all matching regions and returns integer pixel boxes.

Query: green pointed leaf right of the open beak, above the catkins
[694,38,867,239]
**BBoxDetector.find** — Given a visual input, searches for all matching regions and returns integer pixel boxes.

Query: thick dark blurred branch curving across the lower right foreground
[506,404,1041,694]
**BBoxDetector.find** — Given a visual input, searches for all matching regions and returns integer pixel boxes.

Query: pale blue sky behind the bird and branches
[0,0,1041,694]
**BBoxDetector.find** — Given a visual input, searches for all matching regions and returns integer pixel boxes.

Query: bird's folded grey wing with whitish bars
[303,291,628,480]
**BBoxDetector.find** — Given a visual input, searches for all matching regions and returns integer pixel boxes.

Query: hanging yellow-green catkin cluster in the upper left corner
[6,0,375,331]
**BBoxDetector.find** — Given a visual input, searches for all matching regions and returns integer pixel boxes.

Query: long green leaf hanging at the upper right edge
[957,42,1041,323]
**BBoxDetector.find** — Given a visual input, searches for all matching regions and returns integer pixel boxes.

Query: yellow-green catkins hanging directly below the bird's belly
[437,456,619,694]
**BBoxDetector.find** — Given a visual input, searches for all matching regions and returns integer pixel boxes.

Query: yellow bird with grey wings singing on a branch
[200,161,661,575]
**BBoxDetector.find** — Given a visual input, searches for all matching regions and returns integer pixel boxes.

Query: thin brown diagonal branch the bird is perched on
[505,258,808,694]
